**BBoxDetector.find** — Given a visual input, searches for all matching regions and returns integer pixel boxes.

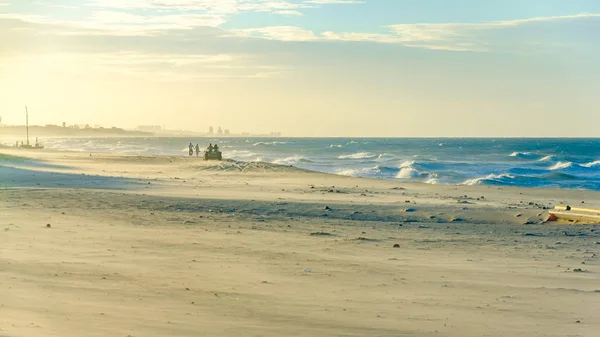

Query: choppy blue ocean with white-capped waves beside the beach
[15,137,600,190]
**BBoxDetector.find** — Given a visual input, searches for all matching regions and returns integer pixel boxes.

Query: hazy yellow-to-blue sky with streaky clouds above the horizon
[0,0,600,137]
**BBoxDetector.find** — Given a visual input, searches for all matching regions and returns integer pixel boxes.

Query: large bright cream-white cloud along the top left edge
[0,0,360,35]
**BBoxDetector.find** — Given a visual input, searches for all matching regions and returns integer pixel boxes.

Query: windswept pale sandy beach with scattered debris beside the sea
[0,149,600,337]
